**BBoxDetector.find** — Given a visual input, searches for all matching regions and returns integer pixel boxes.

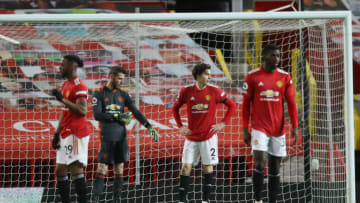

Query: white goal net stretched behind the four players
[0,12,355,203]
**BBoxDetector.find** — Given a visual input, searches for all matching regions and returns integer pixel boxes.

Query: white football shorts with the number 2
[182,134,219,166]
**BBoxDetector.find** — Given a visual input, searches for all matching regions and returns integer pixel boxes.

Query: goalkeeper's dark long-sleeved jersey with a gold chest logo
[92,86,148,141]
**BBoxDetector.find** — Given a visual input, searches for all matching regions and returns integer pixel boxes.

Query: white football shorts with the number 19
[56,135,90,167]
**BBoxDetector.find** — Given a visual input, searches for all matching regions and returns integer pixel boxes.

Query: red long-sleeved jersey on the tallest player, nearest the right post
[242,67,298,136]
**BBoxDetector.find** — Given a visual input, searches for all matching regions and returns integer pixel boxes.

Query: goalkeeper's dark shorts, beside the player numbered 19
[98,137,129,165]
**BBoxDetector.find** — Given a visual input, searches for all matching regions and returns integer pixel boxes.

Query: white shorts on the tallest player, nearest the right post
[251,129,286,157]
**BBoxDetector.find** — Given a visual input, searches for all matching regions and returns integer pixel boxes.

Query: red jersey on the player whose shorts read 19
[61,76,90,138]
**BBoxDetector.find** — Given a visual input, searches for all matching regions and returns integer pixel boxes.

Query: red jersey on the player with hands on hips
[173,84,235,141]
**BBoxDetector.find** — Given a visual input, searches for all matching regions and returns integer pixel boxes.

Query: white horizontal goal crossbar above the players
[0,11,351,22]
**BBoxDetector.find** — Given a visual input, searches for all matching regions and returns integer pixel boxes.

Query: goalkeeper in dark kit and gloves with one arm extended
[92,66,159,201]
